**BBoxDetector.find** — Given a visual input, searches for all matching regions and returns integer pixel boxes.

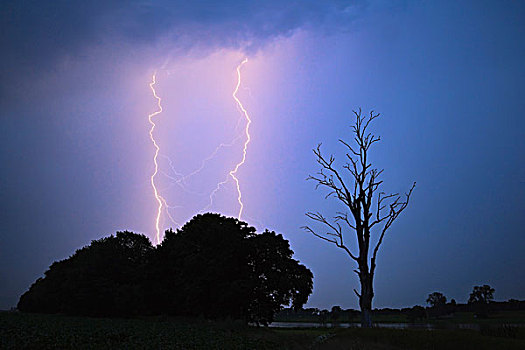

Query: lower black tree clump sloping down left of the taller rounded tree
[18,231,154,316]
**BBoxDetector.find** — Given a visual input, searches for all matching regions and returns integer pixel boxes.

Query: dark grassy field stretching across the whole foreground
[0,312,525,350]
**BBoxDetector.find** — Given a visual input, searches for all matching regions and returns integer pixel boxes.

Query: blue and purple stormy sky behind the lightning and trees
[0,1,525,309]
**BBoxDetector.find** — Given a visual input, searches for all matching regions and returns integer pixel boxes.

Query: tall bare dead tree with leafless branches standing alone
[303,109,416,327]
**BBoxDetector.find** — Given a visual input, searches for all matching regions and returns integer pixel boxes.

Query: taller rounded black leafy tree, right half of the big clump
[150,213,313,324]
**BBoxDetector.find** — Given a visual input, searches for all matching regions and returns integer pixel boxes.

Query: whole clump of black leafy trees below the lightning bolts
[18,213,313,324]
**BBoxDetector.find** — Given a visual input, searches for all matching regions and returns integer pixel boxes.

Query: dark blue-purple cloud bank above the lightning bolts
[0,0,361,85]
